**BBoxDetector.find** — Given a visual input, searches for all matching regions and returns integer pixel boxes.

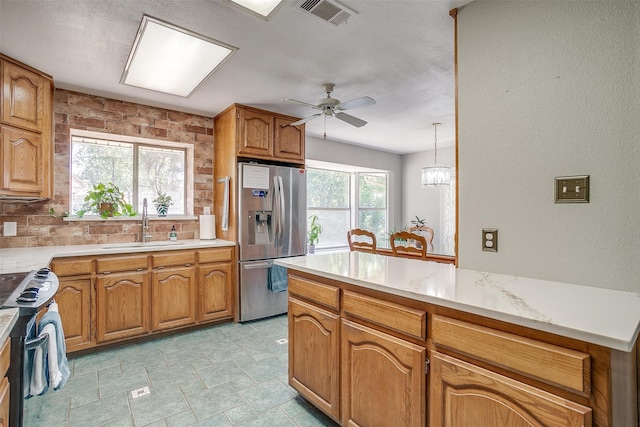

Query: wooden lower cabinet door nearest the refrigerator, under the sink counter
[198,262,234,322]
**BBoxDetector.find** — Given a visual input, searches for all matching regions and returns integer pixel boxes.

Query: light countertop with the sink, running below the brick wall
[0,239,236,274]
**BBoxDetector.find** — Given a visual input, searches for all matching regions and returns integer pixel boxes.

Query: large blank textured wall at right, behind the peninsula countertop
[458,0,640,294]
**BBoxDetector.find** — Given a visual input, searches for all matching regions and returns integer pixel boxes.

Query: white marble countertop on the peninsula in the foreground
[276,252,640,352]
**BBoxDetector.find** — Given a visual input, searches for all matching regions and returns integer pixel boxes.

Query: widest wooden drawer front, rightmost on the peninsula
[431,315,591,395]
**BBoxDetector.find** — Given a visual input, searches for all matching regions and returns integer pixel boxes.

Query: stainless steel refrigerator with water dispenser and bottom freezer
[237,163,307,322]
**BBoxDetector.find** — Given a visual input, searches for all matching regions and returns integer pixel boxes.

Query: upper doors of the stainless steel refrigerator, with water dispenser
[238,163,307,261]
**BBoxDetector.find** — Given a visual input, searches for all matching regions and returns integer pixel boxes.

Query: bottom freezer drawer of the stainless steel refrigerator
[238,260,288,322]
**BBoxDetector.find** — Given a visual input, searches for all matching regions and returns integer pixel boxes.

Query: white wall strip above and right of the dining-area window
[305,136,402,231]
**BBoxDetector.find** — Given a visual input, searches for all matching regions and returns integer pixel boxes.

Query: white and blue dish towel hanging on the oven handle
[31,302,71,394]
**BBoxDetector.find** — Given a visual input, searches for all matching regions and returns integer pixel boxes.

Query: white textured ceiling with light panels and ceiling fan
[0,0,464,154]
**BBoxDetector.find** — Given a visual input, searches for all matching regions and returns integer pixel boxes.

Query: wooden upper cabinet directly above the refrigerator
[214,104,305,165]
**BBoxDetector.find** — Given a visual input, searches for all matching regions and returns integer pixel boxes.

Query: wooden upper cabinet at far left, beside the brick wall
[0,55,53,198]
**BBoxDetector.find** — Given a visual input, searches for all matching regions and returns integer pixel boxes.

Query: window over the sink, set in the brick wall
[69,130,194,216]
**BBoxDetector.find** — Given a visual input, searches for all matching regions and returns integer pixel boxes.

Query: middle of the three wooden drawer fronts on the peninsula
[342,291,427,339]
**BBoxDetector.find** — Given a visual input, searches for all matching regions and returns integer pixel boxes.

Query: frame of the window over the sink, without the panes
[68,128,195,221]
